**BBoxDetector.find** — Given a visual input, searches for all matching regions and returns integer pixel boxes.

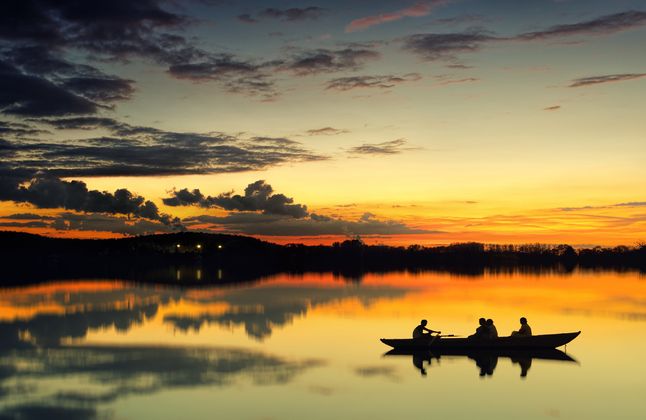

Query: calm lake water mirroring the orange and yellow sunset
[0,272,646,420]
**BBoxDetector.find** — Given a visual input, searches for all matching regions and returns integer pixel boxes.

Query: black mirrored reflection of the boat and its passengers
[384,349,578,378]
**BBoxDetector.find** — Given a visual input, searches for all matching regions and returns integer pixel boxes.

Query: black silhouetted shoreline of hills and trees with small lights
[0,232,646,285]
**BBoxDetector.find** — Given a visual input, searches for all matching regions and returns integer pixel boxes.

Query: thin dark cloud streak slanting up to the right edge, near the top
[515,10,646,41]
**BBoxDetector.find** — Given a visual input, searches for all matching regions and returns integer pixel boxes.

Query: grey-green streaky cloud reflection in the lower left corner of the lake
[0,346,323,419]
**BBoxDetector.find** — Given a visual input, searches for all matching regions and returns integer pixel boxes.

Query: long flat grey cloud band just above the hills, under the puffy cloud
[183,213,437,236]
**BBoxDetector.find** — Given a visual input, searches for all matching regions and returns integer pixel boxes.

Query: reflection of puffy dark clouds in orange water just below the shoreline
[0,284,416,349]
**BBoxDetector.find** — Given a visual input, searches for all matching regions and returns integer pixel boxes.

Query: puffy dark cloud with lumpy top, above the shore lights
[162,180,308,218]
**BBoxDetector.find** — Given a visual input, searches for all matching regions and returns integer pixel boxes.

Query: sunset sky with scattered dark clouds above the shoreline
[0,0,646,246]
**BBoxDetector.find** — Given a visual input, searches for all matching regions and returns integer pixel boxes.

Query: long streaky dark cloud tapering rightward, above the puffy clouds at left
[5,117,325,177]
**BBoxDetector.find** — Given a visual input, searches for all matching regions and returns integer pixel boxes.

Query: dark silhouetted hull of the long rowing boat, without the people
[381,331,581,350]
